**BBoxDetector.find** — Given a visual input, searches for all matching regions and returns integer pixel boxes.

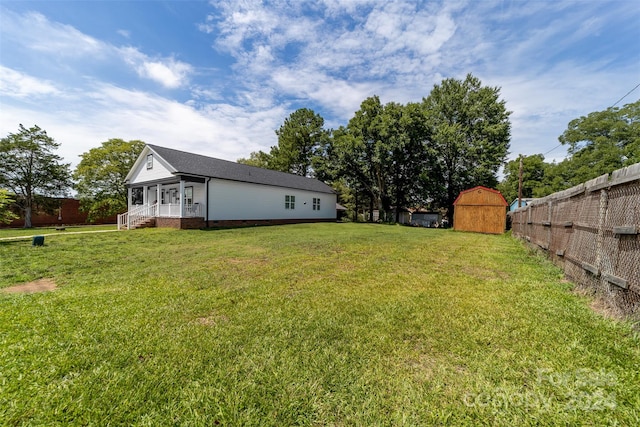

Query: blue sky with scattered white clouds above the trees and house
[0,0,640,171]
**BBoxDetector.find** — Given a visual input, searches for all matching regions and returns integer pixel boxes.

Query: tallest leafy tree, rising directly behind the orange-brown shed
[423,74,511,221]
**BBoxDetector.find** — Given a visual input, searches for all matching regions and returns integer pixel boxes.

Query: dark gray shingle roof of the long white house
[147,144,334,193]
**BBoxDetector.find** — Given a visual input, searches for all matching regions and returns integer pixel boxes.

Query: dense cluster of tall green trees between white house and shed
[238,74,511,221]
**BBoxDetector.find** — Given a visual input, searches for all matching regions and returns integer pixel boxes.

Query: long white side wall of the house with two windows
[209,179,336,221]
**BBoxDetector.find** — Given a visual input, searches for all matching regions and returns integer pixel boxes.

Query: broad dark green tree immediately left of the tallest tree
[318,96,429,221]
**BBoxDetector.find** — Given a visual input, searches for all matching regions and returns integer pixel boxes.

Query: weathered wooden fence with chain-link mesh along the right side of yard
[511,163,640,317]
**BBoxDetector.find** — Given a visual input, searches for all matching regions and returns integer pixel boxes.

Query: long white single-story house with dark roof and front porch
[118,144,336,228]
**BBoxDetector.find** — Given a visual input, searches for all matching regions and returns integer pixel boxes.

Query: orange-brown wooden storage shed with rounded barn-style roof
[453,186,509,234]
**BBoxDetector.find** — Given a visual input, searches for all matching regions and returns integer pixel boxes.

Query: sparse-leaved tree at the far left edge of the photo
[0,125,71,228]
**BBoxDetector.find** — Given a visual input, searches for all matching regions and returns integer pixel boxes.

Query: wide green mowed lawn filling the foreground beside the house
[0,224,640,426]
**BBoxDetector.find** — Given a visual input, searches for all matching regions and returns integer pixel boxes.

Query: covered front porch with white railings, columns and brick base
[118,178,207,230]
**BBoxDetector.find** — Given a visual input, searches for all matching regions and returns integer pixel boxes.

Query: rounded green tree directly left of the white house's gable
[73,138,145,221]
